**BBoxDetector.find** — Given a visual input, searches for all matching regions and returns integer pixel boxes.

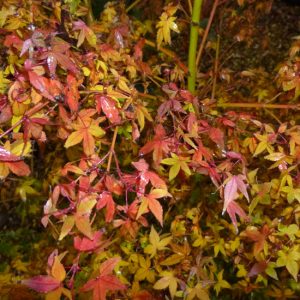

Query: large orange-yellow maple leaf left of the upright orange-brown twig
[65,109,105,156]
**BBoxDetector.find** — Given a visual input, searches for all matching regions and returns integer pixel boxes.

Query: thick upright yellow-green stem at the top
[188,0,202,94]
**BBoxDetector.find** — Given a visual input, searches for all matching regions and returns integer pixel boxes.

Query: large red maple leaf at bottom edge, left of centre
[81,257,126,300]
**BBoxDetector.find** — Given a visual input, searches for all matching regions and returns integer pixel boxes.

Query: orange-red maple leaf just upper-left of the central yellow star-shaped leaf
[139,124,170,165]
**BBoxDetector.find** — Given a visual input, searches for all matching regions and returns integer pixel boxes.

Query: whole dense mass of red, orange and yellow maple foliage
[0,0,300,300]
